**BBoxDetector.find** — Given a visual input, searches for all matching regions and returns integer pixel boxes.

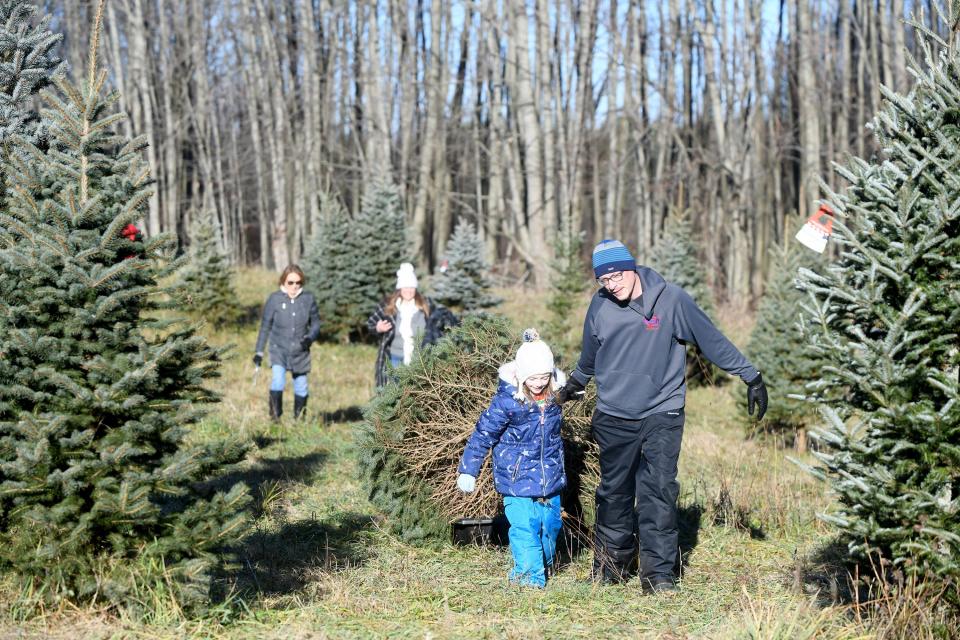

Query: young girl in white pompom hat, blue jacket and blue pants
[457,329,567,588]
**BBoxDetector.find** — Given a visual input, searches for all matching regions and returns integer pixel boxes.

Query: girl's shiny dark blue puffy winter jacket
[459,362,567,498]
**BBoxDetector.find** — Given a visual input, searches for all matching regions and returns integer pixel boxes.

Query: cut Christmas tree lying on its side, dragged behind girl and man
[358,314,599,541]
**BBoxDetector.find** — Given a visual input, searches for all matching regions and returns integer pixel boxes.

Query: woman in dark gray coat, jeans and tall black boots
[253,264,320,420]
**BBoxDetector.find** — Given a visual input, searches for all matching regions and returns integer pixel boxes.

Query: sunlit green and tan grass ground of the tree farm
[0,271,892,640]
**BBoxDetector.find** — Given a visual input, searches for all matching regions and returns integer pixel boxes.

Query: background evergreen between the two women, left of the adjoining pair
[303,193,354,341]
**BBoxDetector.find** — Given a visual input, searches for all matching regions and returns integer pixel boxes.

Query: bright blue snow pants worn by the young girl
[503,494,563,588]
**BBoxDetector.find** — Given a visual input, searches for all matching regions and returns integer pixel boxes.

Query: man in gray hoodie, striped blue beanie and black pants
[558,240,767,592]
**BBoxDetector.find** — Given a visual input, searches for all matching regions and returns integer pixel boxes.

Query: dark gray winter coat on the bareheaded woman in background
[256,291,320,373]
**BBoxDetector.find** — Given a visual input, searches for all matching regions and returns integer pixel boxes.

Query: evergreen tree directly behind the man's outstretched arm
[650,212,722,385]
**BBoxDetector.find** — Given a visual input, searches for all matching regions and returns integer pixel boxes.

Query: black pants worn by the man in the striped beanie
[592,409,684,581]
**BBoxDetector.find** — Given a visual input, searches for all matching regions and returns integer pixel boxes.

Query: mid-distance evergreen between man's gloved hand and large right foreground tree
[746,234,822,433]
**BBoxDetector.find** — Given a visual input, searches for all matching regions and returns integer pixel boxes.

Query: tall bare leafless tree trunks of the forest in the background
[43,0,946,298]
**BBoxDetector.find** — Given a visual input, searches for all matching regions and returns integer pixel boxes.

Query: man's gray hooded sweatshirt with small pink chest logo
[571,267,760,420]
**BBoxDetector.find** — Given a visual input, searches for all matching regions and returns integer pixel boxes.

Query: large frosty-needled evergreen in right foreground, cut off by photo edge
[802,22,960,592]
